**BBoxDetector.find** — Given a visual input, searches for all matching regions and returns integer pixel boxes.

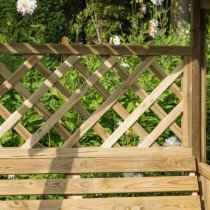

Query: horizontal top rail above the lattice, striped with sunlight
[0,43,192,56]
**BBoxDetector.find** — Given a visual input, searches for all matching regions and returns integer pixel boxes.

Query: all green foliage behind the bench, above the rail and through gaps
[0,0,210,200]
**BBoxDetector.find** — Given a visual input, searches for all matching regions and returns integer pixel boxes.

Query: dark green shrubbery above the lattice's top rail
[0,0,189,44]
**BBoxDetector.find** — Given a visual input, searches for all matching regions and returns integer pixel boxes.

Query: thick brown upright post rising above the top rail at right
[191,0,202,161]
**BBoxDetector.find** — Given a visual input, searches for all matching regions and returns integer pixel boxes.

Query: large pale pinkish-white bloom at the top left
[17,0,37,15]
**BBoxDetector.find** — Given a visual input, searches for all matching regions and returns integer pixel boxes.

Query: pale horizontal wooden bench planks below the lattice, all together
[0,147,201,210]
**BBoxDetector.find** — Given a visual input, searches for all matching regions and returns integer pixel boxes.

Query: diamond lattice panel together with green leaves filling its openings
[0,52,183,148]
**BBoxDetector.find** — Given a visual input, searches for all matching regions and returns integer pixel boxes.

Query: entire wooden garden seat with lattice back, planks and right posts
[0,0,210,210]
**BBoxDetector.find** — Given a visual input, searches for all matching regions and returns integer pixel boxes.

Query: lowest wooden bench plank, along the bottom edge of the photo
[0,196,201,210]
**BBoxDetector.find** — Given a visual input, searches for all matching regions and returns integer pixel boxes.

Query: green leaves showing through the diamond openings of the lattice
[0,50,183,147]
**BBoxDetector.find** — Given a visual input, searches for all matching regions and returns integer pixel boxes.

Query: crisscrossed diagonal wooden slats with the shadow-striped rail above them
[0,44,193,148]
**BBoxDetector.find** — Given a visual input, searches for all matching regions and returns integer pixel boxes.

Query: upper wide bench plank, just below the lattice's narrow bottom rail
[0,155,196,174]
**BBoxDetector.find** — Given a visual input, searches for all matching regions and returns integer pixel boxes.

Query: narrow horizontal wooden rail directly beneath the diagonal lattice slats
[0,147,192,159]
